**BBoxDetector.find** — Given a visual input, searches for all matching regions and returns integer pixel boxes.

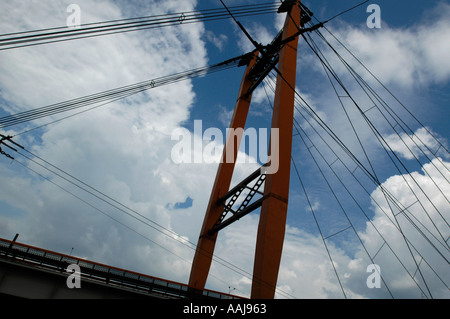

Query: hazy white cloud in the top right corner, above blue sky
[338,3,450,87]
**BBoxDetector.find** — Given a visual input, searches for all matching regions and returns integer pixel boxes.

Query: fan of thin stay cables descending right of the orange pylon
[256,13,450,298]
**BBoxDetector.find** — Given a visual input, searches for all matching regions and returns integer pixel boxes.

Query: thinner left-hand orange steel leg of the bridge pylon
[189,52,258,290]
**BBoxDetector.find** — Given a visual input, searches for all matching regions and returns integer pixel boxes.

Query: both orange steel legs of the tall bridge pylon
[189,0,301,299]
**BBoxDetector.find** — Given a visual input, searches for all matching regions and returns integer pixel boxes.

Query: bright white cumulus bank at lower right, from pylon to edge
[264,159,450,298]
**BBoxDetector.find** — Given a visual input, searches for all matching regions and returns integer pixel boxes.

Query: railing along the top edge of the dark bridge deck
[0,238,242,299]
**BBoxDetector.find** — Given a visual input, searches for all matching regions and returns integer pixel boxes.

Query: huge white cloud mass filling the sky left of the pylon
[0,1,214,281]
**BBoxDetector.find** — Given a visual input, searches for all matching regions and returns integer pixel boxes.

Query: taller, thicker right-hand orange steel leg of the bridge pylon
[251,1,301,299]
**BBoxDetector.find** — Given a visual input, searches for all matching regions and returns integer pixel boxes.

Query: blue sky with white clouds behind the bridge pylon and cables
[0,0,450,299]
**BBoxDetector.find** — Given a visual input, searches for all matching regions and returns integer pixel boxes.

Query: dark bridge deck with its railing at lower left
[0,238,241,299]
